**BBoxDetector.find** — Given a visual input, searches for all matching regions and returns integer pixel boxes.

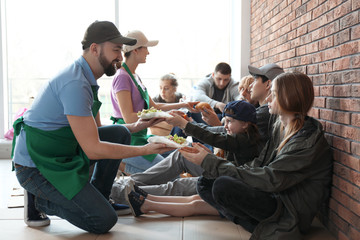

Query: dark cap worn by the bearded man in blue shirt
[81,21,136,50]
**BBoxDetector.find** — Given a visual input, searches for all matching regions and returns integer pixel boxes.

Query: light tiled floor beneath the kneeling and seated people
[0,159,334,240]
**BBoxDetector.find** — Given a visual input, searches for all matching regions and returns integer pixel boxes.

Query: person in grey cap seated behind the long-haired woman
[248,63,284,144]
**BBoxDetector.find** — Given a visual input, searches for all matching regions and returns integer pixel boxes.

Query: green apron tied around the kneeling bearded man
[12,86,101,200]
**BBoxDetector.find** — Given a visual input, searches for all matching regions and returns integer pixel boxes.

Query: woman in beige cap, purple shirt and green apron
[111,30,195,174]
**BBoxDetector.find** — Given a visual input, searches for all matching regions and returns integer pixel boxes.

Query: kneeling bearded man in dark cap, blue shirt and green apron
[13,21,169,234]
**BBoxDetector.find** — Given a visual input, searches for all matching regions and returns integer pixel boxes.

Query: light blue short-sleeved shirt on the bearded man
[13,57,99,167]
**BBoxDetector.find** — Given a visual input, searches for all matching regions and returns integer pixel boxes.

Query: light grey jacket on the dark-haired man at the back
[192,76,239,108]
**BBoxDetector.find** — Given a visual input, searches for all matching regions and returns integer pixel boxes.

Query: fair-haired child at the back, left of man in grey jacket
[150,73,184,136]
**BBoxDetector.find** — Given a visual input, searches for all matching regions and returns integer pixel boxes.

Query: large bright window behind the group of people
[0,0,248,137]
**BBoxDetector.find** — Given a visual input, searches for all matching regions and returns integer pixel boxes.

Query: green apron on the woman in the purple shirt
[110,63,157,162]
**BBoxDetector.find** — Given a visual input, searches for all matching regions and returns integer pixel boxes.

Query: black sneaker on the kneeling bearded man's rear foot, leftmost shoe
[24,190,50,227]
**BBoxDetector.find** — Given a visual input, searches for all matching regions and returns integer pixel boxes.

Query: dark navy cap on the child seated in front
[222,100,256,124]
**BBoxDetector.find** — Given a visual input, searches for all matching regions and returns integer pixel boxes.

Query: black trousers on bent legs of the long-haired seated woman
[197,176,277,232]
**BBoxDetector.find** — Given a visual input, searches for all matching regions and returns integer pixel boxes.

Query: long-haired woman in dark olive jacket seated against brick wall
[125,73,332,239]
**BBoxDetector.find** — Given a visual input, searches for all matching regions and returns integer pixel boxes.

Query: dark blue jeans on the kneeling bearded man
[16,125,131,234]
